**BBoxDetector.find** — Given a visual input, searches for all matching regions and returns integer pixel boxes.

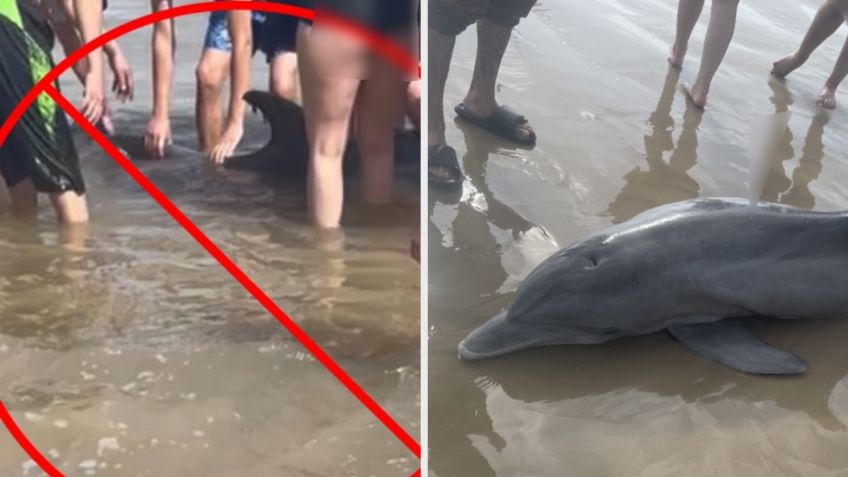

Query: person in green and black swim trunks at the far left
[0,0,105,224]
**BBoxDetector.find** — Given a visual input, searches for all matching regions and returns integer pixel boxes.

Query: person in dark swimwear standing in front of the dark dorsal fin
[297,0,417,229]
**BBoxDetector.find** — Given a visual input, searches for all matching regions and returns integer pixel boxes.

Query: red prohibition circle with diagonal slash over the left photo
[0,0,421,477]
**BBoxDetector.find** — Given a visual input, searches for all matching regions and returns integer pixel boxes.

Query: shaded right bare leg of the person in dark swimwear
[356,53,406,203]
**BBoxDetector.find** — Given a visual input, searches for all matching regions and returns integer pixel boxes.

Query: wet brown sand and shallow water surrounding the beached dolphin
[429,0,848,477]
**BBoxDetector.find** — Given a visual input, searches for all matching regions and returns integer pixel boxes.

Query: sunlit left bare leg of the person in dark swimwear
[297,24,361,228]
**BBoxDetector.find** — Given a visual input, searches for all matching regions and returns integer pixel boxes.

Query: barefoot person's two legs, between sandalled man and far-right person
[668,0,739,108]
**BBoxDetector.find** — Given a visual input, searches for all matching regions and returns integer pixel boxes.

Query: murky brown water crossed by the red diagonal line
[0,2,420,477]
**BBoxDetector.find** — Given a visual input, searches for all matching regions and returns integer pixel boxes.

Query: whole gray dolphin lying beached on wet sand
[459,198,848,374]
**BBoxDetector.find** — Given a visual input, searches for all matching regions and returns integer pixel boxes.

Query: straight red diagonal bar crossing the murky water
[39,86,421,459]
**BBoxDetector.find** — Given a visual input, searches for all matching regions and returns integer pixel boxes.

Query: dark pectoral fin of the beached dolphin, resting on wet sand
[668,320,807,374]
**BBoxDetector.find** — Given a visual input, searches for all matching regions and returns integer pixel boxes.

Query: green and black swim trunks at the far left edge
[0,0,85,194]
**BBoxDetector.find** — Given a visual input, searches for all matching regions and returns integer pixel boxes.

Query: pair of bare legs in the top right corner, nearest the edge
[771,0,848,109]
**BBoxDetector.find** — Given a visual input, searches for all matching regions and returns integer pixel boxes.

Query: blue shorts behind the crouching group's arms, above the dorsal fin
[203,11,298,63]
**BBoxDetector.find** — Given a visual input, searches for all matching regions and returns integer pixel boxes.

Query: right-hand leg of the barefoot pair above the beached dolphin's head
[686,0,739,108]
